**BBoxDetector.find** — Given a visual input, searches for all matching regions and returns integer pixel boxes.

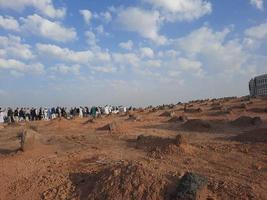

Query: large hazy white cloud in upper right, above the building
[178,27,249,73]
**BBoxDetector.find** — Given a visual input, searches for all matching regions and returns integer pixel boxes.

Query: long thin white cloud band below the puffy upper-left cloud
[36,44,94,64]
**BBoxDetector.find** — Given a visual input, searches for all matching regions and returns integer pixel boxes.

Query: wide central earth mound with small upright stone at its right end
[136,135,192,159]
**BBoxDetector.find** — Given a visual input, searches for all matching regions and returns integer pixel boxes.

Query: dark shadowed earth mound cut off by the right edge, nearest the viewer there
[232,129,267,143]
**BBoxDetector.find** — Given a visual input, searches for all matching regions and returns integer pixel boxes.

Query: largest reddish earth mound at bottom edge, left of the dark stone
[88,162,166,200]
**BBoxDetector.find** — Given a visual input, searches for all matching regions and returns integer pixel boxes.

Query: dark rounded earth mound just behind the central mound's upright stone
[182,119,212,131]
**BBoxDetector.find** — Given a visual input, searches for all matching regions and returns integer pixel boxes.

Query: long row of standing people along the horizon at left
[0,106,127,123]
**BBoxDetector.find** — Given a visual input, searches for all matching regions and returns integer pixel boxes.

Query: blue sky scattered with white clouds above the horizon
[0,0,267,106]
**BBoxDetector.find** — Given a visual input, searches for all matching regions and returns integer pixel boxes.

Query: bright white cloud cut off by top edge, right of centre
[143,0,212,21]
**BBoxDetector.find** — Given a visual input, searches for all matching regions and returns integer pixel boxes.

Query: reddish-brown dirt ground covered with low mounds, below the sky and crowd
[0,98,267,200]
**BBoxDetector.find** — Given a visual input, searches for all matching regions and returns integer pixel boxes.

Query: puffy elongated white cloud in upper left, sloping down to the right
[20,14,77,42]
